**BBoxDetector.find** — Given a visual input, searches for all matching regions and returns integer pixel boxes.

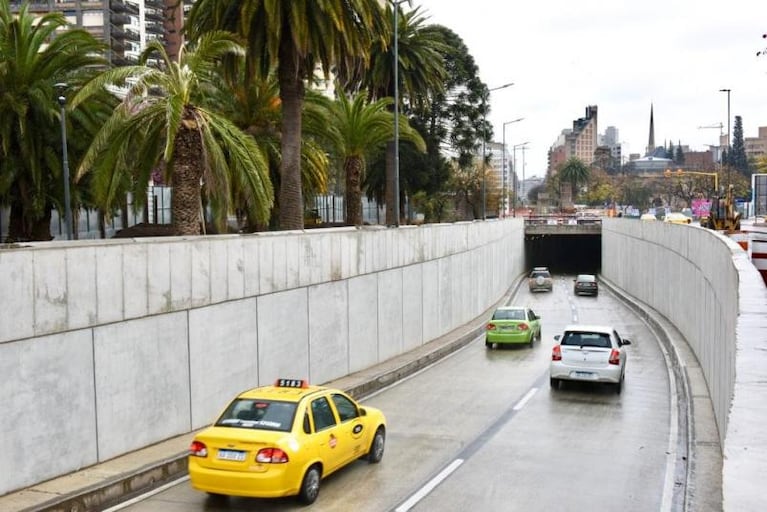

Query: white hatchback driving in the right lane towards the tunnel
[549,325,631,393]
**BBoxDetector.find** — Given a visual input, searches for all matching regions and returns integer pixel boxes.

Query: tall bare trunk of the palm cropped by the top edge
[278,38,304,229]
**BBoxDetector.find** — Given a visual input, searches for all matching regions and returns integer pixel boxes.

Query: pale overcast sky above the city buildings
[413,0,767,177]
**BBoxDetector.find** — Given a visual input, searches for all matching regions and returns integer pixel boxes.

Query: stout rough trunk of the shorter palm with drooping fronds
[171,126,204,235]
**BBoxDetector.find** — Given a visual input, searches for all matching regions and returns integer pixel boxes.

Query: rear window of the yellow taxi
[216,398,296,432]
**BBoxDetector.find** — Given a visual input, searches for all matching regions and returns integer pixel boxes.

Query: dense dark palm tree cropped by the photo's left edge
[0,0,105,240]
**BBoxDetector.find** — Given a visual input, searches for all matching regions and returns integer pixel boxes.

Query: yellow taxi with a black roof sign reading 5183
[189,379,386,504]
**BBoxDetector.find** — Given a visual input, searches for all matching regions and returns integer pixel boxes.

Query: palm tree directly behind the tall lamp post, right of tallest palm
[341,2,450,224]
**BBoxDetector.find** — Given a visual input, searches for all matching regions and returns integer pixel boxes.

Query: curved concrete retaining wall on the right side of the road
[602,219,767,511]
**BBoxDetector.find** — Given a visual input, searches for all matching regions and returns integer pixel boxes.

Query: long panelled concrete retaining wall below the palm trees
[0,219,524,494]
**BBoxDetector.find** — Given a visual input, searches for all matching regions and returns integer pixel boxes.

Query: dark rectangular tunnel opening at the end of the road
[525,234,602,274]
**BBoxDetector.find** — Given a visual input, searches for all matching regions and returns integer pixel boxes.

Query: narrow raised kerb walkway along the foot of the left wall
[0,300,498,512]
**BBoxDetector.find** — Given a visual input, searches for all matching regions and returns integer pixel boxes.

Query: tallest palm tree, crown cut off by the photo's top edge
[187,0,386,229]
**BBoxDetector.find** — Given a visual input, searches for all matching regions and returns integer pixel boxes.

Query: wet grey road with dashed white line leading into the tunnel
[112,276,676,512]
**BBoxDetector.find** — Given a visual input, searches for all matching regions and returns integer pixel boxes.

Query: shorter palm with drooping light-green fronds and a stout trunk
[72,32,273,235]
